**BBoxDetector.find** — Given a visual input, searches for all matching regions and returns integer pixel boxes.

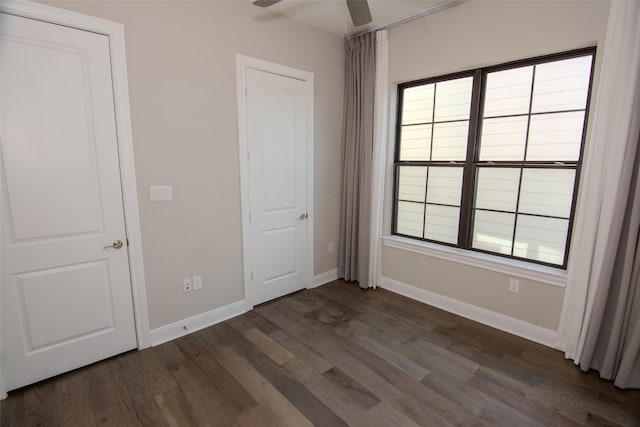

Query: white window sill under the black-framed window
[382,236,567,287]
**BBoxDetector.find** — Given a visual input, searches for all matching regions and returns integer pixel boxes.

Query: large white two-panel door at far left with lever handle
[0,13,136,390]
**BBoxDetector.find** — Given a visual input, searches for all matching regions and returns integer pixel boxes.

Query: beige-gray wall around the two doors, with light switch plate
[47,1,344,329]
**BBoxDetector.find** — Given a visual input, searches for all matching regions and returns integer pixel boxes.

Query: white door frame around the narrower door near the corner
[236,54,314,311]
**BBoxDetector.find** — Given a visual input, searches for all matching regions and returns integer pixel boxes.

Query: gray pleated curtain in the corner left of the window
[338,32,376,288]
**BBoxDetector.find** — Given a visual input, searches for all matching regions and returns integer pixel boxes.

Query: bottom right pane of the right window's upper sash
[527,111,584,161]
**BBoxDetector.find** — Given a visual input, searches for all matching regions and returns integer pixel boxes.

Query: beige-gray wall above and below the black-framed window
[383,0,609,330]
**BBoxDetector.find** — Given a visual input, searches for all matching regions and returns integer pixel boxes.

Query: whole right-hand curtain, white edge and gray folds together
[558,0,640,388]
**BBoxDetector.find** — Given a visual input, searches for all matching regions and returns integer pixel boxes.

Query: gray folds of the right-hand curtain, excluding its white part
[580,84,640,388]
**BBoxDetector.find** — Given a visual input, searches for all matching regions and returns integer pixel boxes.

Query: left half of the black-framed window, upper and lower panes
[396,73,473,245]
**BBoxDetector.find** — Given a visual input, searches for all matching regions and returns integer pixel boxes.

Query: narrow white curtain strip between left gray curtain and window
[367,30,389,289]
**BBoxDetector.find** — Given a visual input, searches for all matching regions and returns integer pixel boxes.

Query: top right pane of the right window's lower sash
[518,169,576,218]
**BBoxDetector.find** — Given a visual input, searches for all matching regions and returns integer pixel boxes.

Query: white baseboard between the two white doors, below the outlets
[149,300,247,347]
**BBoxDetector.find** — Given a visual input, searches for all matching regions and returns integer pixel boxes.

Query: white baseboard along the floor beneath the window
[380,277,557,348]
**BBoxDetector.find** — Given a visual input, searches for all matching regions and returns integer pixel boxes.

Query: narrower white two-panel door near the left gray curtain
[246,68,308,304]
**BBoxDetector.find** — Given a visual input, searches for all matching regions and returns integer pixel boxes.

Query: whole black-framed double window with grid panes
[393,49,595,268]
